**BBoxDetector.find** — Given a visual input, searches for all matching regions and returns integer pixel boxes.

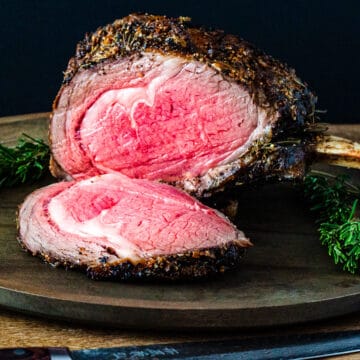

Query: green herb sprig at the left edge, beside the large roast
[0,134,50,188]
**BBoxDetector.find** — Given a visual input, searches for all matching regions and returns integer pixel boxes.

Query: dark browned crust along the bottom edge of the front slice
[18,238,246,281]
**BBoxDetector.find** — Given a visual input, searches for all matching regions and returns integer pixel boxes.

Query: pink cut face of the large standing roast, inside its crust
[52,54,266,182]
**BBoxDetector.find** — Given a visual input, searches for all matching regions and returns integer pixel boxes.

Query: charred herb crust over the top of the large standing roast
[63,14,316,138]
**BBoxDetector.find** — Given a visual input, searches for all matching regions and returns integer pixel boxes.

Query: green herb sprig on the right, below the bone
[305,172,360,274]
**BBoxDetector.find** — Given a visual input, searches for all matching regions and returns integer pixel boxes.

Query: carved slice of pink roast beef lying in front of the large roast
[19,174,251,280]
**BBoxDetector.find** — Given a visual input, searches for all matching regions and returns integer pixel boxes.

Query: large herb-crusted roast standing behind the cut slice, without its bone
[50,14,316,196]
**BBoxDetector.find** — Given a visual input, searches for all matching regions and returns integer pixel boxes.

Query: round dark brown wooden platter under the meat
[0,114,360,329]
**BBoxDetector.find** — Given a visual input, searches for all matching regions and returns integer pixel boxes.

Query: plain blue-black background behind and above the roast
[0,0,360,123]
